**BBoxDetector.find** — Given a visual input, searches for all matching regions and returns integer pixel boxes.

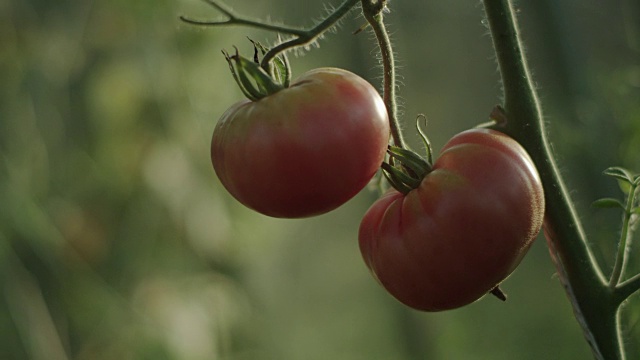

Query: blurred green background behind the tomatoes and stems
[0,0,640,360]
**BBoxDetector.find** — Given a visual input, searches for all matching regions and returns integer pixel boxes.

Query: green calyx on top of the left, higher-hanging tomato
[222,39,291,101]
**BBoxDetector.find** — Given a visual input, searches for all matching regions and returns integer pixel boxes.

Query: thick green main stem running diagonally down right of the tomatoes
[484,0,624,360]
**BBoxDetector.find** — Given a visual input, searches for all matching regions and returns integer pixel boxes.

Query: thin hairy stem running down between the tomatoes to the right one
[362,0,406,148]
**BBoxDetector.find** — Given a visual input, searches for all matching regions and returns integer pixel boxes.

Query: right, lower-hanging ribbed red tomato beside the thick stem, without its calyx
[359,129,544,311]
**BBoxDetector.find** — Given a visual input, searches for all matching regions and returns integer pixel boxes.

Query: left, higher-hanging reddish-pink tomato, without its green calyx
[211,68,389,218]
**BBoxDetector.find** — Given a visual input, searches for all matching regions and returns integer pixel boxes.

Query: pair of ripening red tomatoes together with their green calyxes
[211,55,544,311]
